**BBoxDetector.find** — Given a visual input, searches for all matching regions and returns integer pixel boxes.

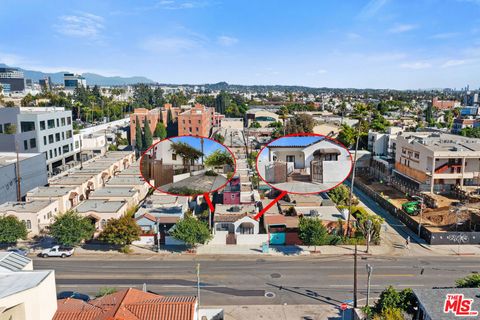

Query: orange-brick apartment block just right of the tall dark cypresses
[178,103,217,137]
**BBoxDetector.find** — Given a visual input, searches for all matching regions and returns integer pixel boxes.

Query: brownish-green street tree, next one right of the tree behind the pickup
[99,215,142,247]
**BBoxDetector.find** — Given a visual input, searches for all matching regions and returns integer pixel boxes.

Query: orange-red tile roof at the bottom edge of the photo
[53,288,197,320]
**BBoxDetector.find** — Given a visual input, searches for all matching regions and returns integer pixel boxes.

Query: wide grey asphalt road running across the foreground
[34,256,480,305]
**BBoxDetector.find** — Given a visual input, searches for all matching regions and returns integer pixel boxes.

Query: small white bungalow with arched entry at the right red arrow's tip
[211,204,267,245]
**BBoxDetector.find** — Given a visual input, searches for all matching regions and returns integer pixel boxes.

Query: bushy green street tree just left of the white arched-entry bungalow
[171,215,212,247]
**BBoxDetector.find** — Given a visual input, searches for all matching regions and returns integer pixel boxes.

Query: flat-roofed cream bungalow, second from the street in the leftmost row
[25,186,80,213]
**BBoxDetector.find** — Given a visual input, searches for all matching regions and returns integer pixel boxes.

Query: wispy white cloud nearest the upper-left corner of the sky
[54,12,105,39]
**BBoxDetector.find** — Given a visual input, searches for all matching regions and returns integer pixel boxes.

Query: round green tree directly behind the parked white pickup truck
[50,210,95,246]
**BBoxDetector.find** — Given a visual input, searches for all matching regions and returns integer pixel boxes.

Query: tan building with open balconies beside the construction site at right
[393,132,480,193]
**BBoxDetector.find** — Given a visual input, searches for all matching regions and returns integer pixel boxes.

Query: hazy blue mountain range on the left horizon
[0,63,155,86]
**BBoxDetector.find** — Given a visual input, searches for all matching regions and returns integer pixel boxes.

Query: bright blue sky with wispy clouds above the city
[0,0,480,89]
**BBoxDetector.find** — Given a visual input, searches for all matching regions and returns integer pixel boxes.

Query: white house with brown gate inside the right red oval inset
[264,137,352,188]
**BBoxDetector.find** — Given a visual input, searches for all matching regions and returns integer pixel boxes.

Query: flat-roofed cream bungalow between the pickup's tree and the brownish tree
[74,199,129,231]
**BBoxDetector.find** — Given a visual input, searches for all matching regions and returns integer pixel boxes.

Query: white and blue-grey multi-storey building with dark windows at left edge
[0,107,75,173]
